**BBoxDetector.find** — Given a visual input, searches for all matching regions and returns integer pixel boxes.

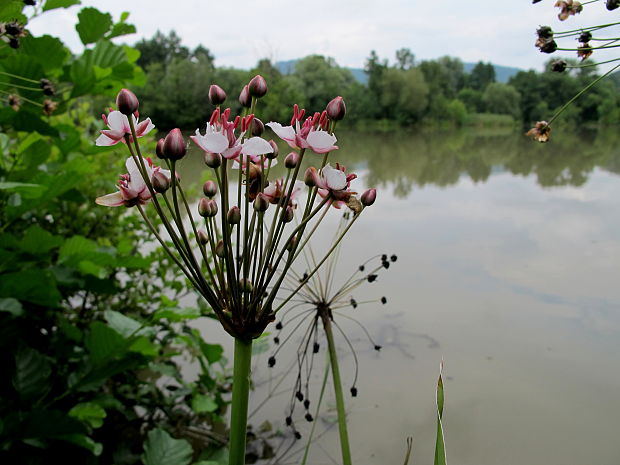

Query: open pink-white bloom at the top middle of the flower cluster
[190,109,273,161]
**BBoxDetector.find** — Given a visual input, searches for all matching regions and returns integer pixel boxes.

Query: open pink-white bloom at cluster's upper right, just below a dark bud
[267,105,338,153]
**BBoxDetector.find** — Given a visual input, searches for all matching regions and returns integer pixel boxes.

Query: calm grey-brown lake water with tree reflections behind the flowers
[182,127,620,465]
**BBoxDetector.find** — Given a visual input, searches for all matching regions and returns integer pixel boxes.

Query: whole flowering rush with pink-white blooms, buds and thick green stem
[96,80,376,465]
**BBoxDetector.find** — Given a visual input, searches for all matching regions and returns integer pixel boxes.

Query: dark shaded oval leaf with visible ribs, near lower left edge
[13,347,52,399]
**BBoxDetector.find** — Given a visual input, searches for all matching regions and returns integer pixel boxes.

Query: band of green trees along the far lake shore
[134,31,620,130]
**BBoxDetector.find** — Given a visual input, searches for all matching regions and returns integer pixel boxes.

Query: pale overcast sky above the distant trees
[30,0,620,69]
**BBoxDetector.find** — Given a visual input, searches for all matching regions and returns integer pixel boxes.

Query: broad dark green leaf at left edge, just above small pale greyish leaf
[0,269,62,307]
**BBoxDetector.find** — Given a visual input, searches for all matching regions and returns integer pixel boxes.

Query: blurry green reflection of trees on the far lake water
[338,130,620,197]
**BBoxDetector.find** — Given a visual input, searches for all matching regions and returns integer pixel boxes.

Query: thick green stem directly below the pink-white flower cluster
[228,338,252,465]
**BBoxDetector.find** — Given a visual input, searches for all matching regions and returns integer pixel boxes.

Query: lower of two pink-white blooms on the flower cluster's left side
[95,157,171,207]
